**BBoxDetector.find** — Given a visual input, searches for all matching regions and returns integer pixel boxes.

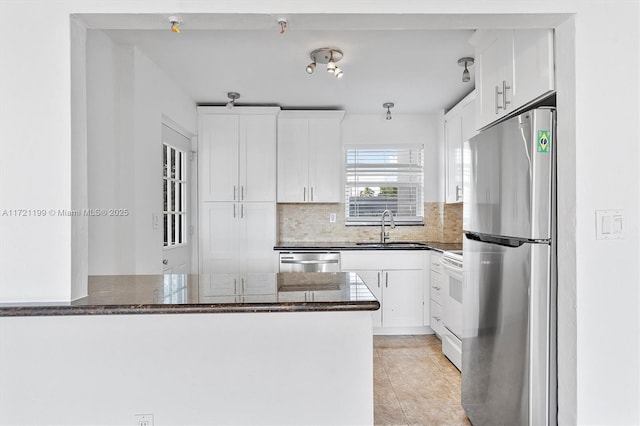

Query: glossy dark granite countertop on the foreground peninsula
[0,272,380,317]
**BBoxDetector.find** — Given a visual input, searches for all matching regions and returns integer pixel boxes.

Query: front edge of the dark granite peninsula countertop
[0,300,380,318]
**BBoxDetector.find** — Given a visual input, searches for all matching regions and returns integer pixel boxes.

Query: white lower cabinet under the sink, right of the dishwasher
[340,250,429,334]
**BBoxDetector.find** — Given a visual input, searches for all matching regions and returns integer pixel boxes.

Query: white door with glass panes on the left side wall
[161,124,191,274]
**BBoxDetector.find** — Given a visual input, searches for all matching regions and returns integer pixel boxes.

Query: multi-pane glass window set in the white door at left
[162,143,187,247]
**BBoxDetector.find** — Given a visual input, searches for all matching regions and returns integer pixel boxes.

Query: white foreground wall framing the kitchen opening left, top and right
[0,0,640,424]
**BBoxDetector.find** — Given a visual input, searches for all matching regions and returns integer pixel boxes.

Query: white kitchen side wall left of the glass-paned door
[87,30,196,275]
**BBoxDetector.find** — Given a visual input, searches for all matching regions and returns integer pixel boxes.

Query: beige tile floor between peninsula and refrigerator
[373,335,471,426]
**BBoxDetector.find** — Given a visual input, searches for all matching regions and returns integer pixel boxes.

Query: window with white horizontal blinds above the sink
[345,145,424,225]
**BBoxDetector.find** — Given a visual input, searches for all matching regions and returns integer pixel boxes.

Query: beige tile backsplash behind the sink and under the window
[278,203,462,243]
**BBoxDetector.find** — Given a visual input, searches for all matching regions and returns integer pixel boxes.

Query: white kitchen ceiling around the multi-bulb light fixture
[107,28,474,113]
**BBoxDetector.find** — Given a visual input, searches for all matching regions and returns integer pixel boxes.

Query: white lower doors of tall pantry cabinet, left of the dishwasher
[199,201,277,298]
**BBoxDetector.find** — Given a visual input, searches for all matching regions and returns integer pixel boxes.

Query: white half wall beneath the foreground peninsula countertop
[0,311,373,425]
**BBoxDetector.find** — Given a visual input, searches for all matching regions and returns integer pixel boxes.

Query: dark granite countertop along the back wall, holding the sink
[273,241,462,252]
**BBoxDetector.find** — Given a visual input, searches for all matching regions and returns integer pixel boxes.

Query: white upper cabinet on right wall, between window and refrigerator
[444,91,476,203]
